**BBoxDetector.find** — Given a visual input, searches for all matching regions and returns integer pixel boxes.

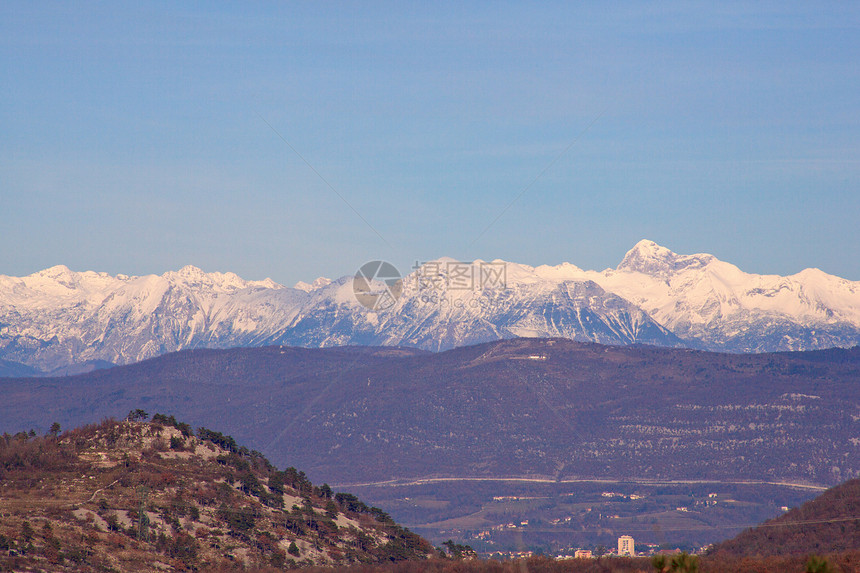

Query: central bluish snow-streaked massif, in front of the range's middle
[272,266,683,351]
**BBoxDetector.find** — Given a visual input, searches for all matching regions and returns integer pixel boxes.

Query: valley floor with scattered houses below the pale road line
[337,478,825,556]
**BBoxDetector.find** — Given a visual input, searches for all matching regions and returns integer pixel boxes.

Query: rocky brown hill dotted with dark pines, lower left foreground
[0,411,433,571]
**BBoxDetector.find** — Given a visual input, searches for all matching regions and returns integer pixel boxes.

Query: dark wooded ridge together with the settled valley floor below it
[0,339,860,552]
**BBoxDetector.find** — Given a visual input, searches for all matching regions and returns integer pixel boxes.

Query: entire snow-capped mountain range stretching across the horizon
[0,240,860,371]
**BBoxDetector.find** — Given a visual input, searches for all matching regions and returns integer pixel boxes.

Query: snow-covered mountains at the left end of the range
[0,266,306,370]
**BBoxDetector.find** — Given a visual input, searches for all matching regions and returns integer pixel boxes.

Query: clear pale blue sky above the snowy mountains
[0,1,860,285]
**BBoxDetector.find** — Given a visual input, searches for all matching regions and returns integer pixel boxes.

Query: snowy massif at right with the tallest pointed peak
[586,241,860,352]
